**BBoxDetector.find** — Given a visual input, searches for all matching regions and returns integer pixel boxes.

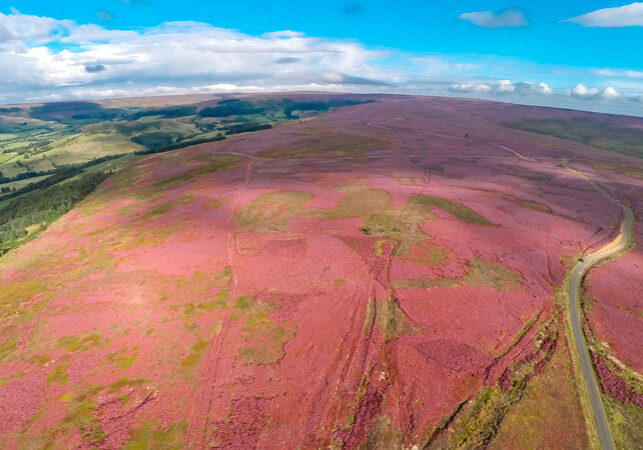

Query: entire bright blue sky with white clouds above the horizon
[0,0,643,115]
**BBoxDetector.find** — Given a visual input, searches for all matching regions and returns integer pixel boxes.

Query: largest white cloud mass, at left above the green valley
[0,14,388,98]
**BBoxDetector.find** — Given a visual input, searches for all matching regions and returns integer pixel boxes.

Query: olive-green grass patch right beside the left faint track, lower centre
[233,296,295,366]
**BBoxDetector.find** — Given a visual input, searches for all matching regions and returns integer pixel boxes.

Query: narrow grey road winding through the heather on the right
[569,170,634,450]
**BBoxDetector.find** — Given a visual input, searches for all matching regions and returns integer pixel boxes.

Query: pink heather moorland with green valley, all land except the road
[0,94,643,449]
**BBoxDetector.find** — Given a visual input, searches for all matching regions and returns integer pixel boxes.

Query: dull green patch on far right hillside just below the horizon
[502,117,643,158]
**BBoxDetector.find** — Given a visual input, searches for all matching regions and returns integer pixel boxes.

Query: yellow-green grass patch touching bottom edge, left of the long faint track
[123,419,188,450]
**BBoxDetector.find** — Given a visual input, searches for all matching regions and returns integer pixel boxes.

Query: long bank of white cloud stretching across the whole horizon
[0,11,643,115]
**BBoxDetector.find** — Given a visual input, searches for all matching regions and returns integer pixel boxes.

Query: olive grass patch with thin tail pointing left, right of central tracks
[393,256,523,291]
